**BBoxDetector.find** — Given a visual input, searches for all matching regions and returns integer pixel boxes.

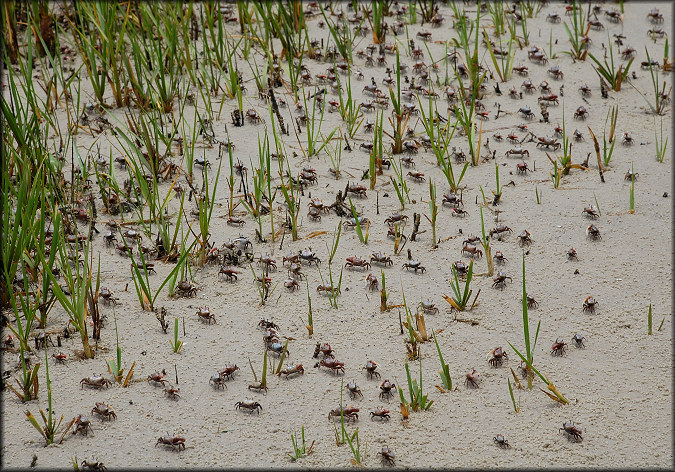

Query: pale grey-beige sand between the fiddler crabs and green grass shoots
[2,2,673,470]
